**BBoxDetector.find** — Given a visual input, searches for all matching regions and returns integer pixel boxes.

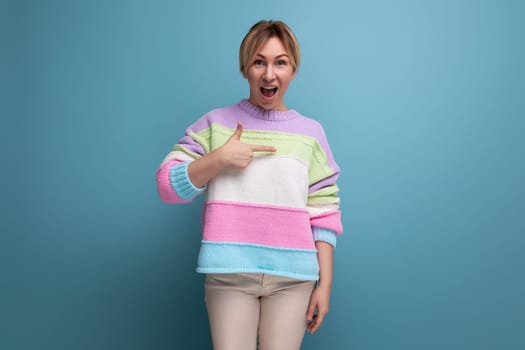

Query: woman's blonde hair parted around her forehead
[239,20,301,75]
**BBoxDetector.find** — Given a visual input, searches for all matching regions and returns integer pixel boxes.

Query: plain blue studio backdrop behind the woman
[0,0,525,350]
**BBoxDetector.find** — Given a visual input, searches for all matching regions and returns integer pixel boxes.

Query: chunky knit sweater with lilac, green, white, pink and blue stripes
[157,100,342,280]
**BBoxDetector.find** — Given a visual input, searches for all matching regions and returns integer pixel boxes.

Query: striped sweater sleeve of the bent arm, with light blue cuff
[157,120,209,203]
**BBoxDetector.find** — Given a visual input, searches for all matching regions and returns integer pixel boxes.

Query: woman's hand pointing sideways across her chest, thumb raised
[216,122,277,169]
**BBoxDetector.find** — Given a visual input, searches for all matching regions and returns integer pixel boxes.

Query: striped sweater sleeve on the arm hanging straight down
[307,123,343,247]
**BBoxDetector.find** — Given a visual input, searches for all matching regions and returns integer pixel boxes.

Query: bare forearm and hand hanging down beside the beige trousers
[306,241,334,334]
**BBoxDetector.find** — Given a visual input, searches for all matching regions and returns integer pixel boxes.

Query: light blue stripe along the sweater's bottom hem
[197,241,319,281]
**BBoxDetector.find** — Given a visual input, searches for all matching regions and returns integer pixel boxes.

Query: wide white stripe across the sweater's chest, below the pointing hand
[207,156,308,209]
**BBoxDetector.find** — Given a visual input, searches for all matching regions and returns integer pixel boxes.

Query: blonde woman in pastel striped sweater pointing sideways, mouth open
[157,21,342,350]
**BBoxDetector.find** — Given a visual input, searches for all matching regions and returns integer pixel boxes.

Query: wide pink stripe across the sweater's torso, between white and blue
[203,201,315,249]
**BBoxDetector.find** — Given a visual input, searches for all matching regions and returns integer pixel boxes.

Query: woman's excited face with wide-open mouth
[244,37,295,111]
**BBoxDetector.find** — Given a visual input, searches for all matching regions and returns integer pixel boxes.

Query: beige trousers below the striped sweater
[205,273,315,350]
